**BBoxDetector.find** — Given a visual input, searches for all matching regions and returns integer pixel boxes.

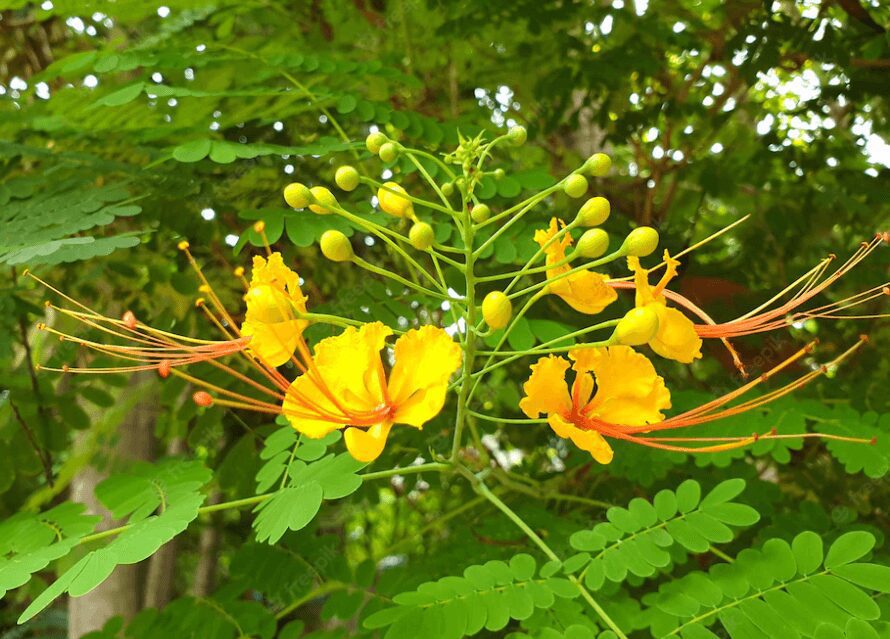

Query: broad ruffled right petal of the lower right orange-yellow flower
[569,346,671,426]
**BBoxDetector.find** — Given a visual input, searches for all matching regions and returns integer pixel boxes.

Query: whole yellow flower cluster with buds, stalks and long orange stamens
[31,127,890,464]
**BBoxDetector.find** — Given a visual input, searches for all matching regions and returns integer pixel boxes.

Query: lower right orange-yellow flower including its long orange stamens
[519,339,868,464]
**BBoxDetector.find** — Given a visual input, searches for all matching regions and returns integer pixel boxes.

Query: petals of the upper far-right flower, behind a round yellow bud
[627,251,701,364]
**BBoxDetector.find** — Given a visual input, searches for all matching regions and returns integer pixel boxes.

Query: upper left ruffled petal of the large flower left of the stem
[313,322,392,411]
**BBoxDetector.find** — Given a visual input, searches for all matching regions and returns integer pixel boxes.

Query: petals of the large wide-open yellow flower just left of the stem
[282,322,461,462]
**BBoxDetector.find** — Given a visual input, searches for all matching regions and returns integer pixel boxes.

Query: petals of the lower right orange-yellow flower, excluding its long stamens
[519,346,671,464]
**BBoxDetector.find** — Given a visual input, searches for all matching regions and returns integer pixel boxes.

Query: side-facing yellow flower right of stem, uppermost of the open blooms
[535,218,618,315]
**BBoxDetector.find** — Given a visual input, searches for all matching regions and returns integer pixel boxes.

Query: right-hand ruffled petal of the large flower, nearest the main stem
[388,326,461,428]
